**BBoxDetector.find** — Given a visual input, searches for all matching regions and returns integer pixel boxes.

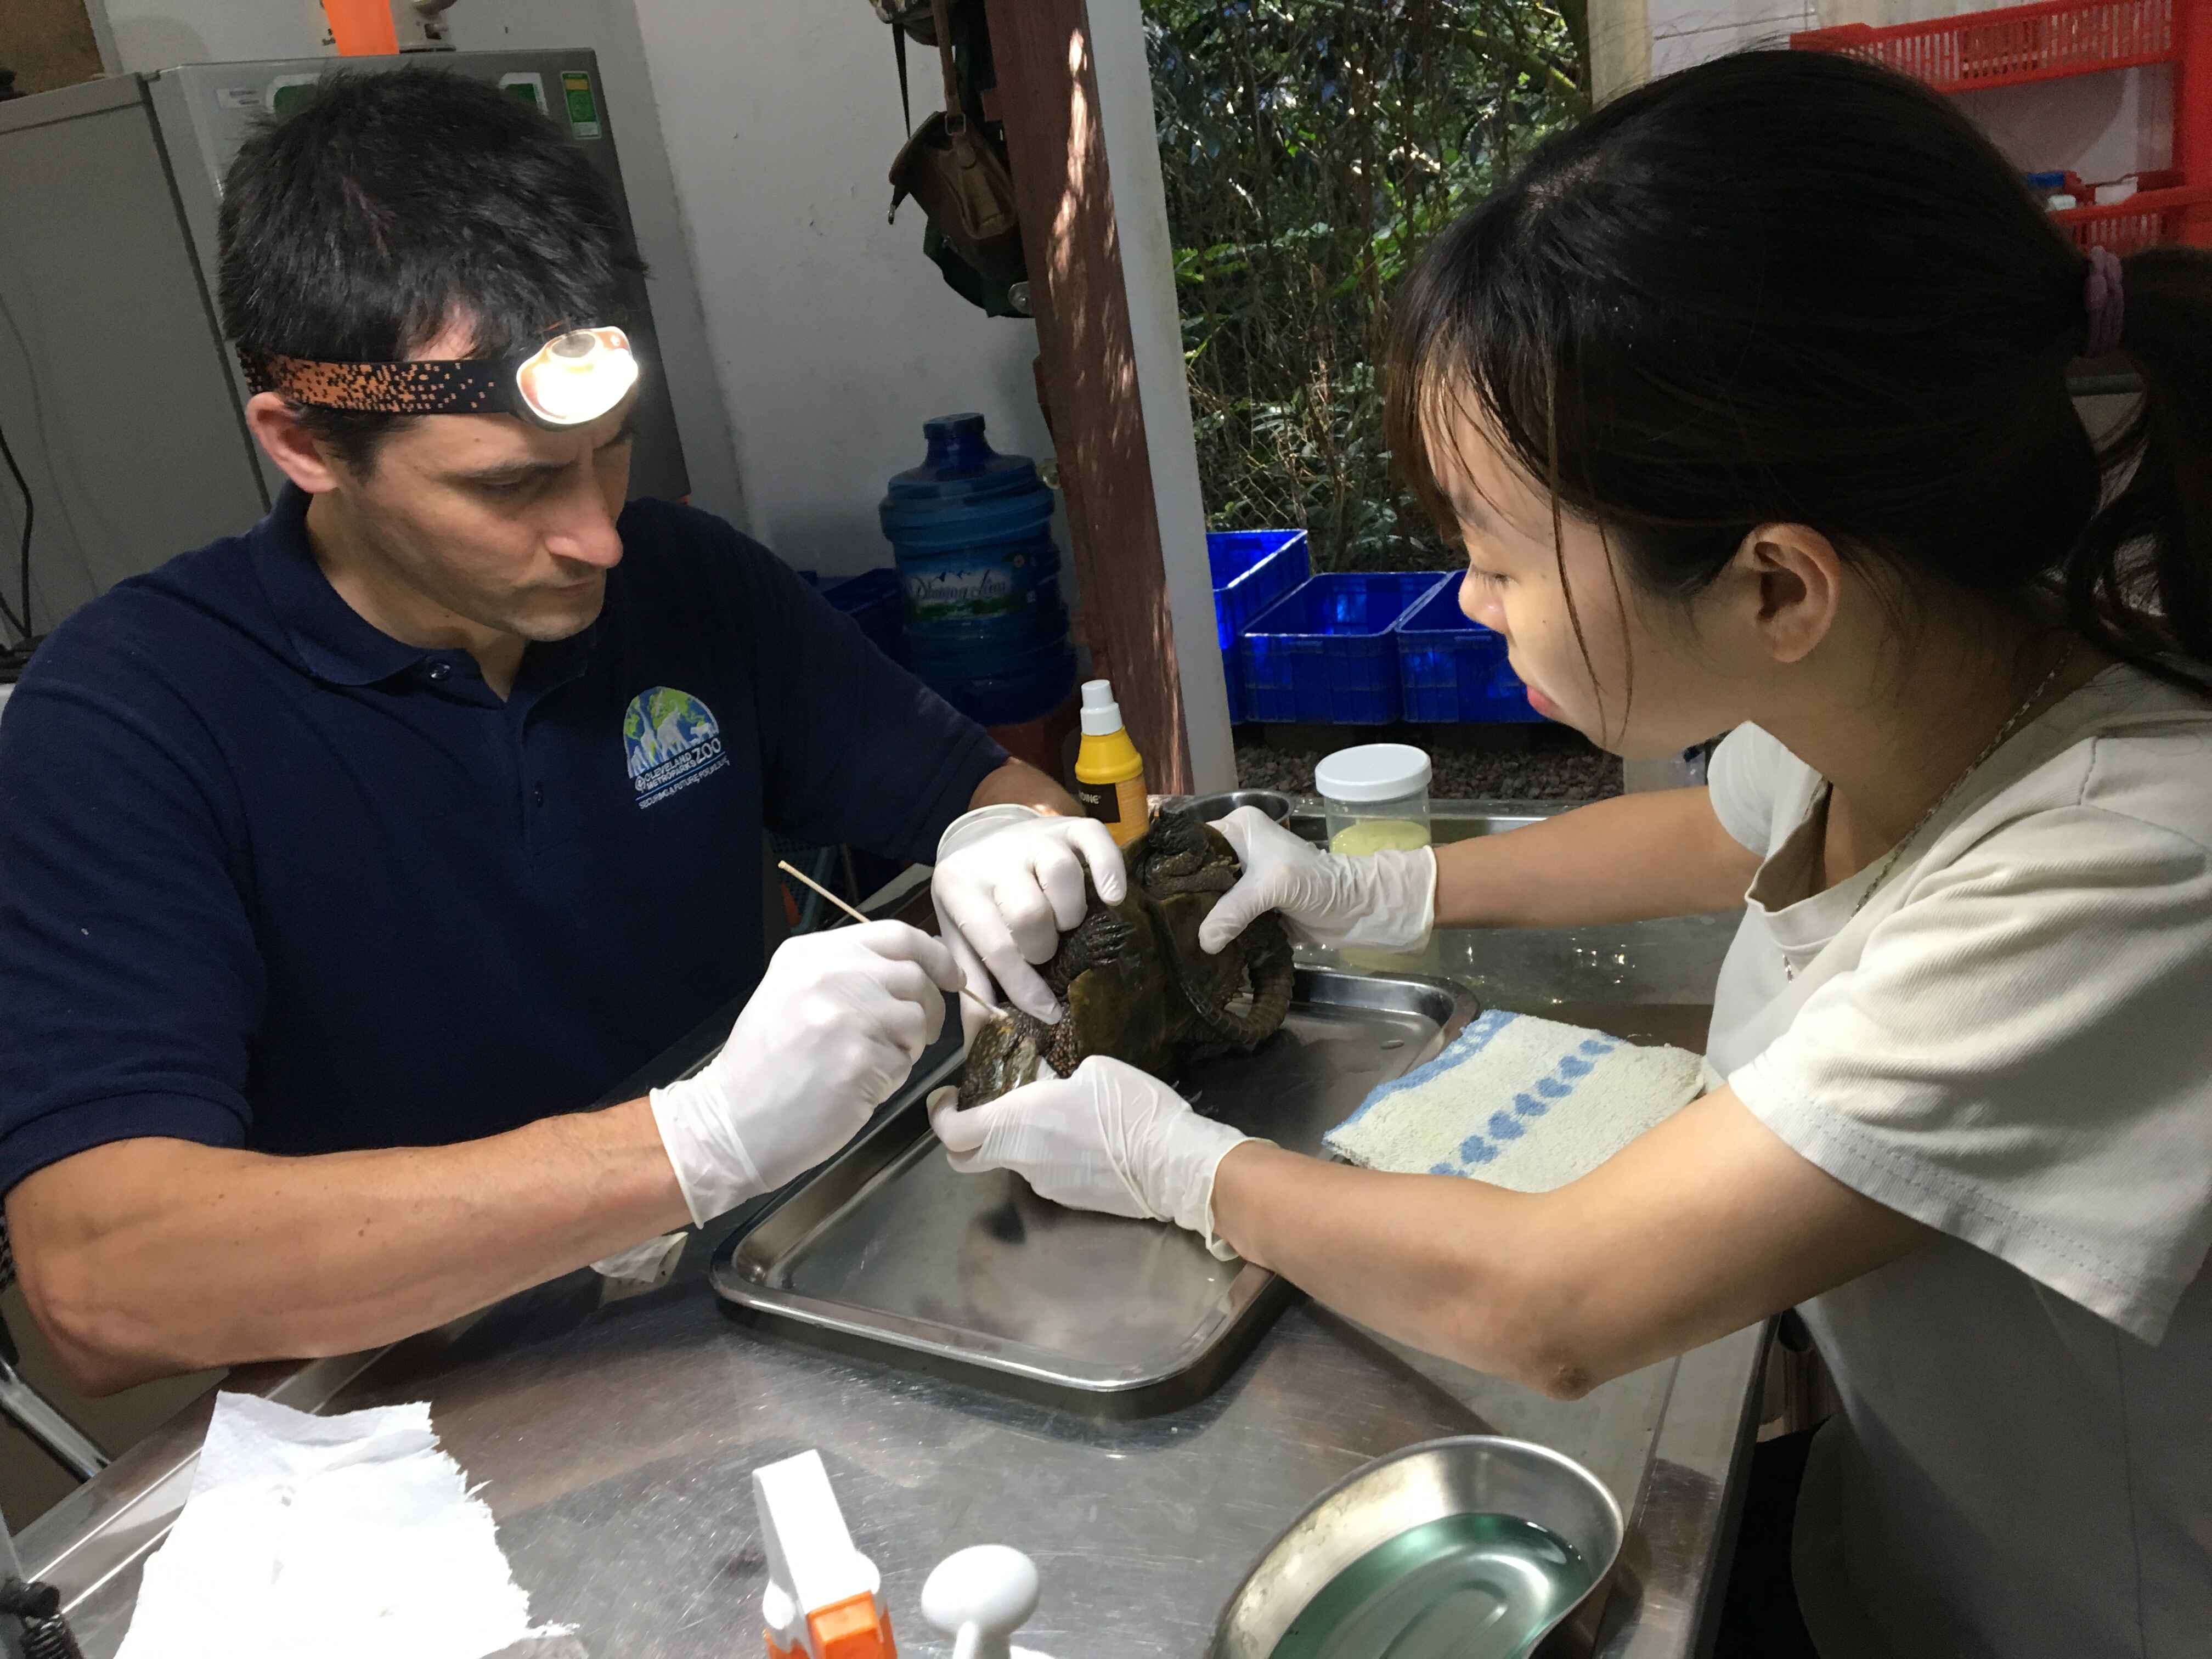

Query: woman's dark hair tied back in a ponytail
[1389,51,2212,716]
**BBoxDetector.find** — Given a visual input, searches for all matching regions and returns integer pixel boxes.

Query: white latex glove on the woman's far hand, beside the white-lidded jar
[1199,808,1436,953]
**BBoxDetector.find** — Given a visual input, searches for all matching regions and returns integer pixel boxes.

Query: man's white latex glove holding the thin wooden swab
[652,922,960,1226]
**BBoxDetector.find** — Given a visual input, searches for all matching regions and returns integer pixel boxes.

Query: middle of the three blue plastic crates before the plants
[1239,571,1455,725]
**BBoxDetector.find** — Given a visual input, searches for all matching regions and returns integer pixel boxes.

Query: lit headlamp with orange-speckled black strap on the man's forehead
[239,328,637,431]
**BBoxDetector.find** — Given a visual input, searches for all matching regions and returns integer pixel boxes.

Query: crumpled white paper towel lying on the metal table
[117,1393,566,1659]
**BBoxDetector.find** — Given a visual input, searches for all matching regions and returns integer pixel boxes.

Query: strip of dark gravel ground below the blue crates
[1237,725,1621,801]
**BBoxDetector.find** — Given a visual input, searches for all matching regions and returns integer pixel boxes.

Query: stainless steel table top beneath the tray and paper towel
[20,814,1763,1659]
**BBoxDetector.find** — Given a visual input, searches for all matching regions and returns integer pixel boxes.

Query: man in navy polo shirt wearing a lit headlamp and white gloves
[0,69,1121,1389]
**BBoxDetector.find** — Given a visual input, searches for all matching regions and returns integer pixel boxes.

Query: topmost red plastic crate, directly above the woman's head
[1790,0,2188,93]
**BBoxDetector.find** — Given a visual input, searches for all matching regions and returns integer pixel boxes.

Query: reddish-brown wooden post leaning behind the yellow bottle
[986,0,1234,794]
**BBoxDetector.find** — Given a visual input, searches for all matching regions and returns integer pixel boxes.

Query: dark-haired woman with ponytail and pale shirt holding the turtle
[940,53,2212,1659]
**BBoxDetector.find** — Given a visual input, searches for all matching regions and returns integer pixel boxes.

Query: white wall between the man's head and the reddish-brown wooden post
[610,0,1051,571]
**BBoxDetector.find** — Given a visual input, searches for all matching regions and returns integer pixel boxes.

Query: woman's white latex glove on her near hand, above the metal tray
[929,1055,1254,1261]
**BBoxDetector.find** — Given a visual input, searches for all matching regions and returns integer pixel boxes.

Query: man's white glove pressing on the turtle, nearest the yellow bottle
[929,808,1128,1024]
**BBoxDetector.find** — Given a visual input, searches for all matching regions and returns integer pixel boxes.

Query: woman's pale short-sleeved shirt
[1708,668,2212,1659]
